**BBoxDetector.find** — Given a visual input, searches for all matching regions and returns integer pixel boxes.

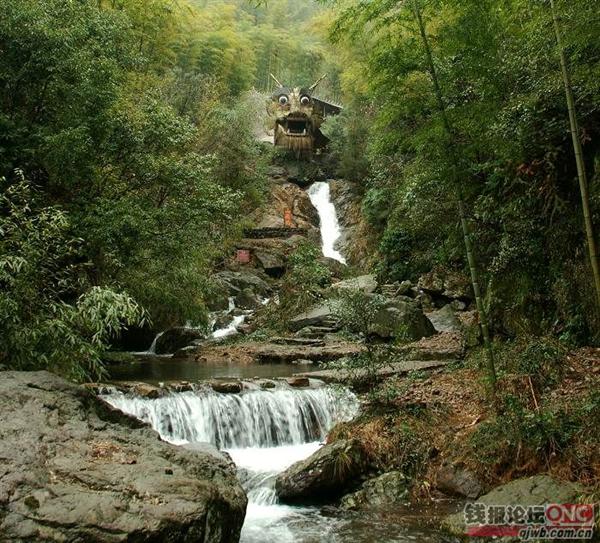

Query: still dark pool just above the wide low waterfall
[109,356,318,384]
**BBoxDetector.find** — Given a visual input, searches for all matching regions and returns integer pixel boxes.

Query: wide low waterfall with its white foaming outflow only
[102,385,358,543]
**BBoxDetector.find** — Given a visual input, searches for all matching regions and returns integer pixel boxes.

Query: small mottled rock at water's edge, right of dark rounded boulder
[340,471,410,511]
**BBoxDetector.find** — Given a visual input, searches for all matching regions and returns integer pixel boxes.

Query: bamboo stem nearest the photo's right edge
[550,0,600,308]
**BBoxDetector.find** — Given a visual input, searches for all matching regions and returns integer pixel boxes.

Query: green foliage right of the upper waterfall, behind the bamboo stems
[332,0,600,343]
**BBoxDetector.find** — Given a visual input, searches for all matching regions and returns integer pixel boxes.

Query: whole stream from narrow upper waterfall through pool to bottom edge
[102,182,454,543]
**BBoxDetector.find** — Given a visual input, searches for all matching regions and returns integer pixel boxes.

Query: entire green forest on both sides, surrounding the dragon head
[0,0,600,376]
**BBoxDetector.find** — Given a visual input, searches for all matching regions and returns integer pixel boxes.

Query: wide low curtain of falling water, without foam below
[102,386,356,449]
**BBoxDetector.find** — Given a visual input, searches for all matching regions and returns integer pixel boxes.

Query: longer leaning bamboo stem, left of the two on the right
[413,0,496,390]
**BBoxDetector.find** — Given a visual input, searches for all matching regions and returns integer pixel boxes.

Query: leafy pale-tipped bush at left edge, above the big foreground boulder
[0,178,143,381]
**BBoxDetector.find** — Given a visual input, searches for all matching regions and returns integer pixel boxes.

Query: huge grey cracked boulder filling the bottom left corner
[0,372,246,543]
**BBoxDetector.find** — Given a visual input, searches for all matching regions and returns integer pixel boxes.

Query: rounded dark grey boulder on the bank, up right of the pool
[369,298,435,341]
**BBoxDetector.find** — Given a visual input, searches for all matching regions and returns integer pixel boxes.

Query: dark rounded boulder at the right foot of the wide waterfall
[275,439,366,503]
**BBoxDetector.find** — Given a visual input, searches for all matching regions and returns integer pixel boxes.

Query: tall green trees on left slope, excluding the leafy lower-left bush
[0,0,276,336]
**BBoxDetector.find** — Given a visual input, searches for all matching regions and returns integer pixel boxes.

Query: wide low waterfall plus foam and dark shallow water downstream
[102,383,452,543]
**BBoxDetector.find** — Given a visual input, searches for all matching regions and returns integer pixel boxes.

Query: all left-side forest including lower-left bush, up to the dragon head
[0,0,338,373]
